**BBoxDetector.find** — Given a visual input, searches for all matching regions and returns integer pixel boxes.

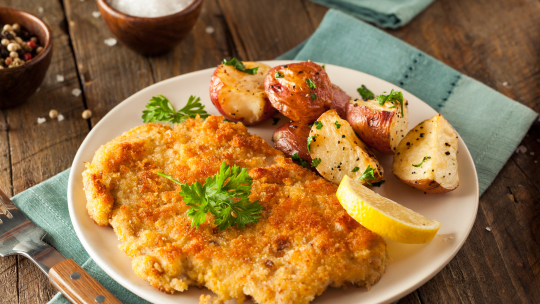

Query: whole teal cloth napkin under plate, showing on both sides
[6,10,537,304]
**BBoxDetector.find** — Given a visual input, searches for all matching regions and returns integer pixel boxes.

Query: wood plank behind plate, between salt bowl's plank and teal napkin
[219,0,315,60]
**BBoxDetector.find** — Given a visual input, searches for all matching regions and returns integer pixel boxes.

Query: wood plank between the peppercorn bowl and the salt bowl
[64,0,154,125]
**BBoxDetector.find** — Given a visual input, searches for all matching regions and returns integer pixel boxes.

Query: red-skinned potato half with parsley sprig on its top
[347,99,409,154]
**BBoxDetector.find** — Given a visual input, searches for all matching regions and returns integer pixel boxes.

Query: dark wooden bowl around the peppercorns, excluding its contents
[0,7,52,109]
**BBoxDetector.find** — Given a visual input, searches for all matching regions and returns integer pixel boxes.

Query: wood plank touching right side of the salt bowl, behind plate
[149,0,237,82]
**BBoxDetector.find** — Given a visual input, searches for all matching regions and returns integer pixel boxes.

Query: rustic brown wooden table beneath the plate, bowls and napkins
[0,0,540,303]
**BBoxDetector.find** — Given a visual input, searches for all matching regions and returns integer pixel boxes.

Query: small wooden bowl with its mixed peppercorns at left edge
[0,7,52,109]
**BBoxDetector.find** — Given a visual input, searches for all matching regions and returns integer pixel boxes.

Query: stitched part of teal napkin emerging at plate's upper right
[278,10,538,194]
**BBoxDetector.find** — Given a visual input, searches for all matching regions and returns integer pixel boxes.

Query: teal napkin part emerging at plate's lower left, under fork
[11,169,148,304]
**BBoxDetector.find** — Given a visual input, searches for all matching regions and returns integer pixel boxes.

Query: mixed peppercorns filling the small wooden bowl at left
[0,23,43,69]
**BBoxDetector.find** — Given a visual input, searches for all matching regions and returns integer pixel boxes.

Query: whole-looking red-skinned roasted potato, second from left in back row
[264,62,333,124]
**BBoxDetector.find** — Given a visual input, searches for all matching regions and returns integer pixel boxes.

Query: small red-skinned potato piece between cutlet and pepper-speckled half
[272,121,312,164]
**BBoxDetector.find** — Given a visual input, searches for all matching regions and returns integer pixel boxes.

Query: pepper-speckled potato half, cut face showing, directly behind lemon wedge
[309,110,383,184]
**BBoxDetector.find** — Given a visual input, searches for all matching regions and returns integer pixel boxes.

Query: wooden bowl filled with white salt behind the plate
[97,0,203,56]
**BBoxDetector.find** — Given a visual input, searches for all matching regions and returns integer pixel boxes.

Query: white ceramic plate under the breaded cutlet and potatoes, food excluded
[68,61,479,304]
